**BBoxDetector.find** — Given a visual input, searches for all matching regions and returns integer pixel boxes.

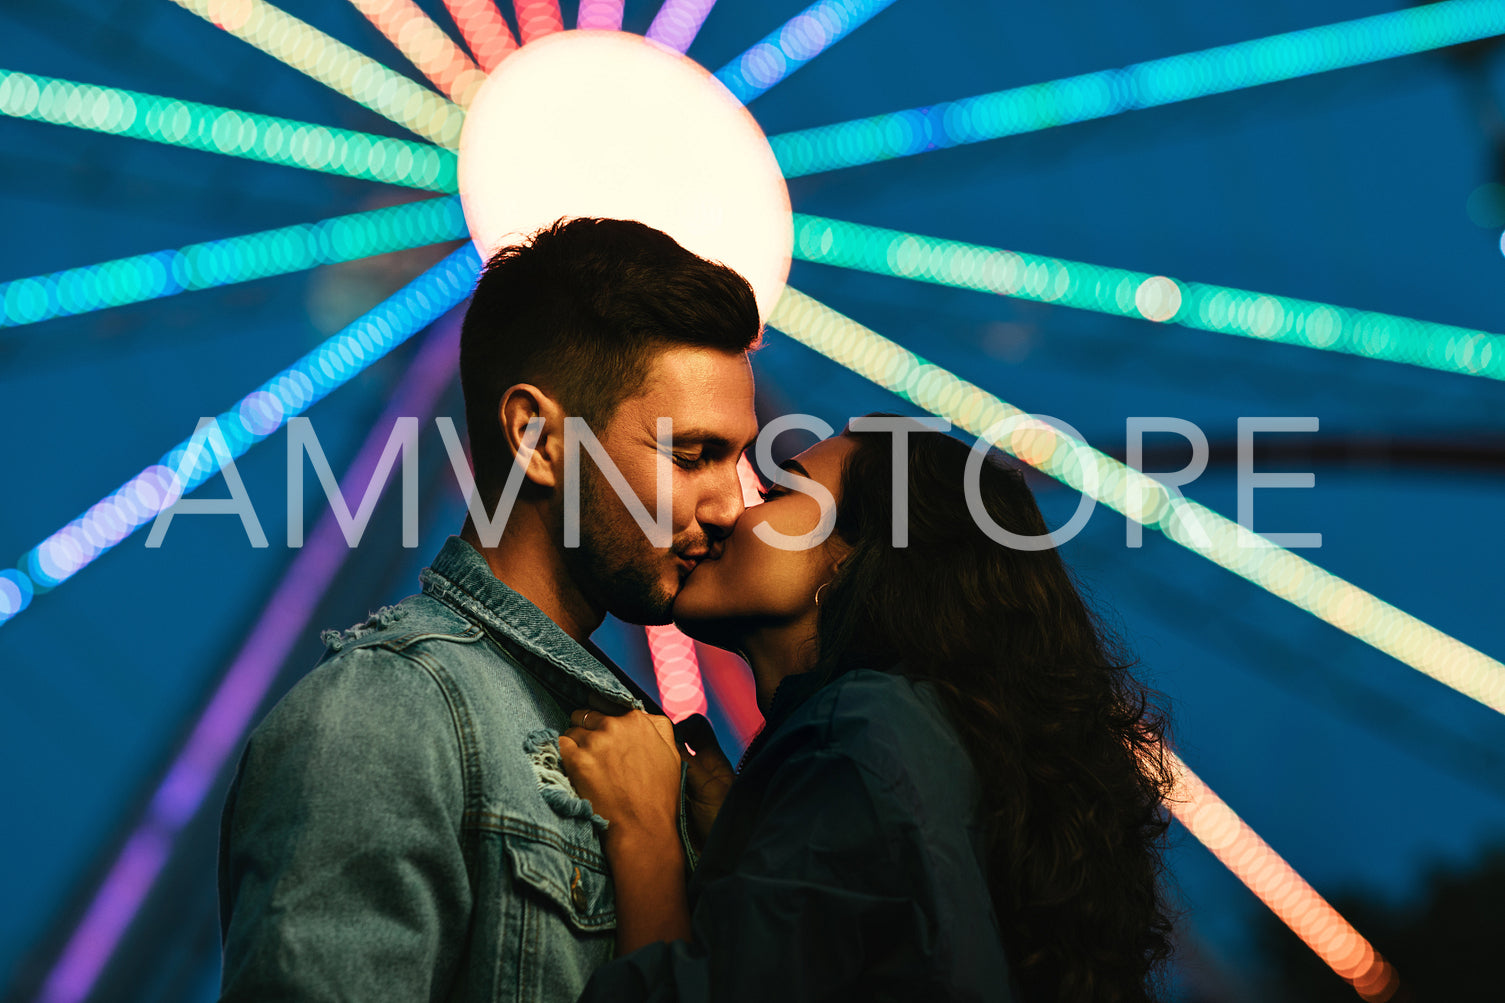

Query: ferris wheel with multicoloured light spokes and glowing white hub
[0,0,1505,1000]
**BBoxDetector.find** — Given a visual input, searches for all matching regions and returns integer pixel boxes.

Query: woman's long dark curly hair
[814,416,1175,1003]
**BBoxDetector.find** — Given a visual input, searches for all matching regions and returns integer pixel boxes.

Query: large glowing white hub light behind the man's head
[459,30,795,319]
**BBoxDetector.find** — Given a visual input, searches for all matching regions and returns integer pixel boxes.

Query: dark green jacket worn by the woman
[581,670,1022,1003]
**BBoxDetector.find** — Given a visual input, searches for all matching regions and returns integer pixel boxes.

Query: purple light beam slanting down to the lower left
[38,304,461,1003]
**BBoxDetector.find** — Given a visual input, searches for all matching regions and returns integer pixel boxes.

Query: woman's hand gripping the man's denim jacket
[560,709,680,854]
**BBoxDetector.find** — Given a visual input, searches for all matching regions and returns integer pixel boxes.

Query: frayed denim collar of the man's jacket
[418,536,643,708]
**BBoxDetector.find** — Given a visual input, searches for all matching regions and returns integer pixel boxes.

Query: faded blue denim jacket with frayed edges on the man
[218,536,688,1003]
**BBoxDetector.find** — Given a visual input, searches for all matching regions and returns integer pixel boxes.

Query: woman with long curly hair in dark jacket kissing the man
[560,412,1172,1003]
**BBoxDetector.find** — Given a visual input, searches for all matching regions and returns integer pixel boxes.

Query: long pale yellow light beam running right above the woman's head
[769,286,1505,714]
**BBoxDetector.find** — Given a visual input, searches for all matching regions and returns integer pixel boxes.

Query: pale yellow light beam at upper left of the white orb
[164,0,465,149]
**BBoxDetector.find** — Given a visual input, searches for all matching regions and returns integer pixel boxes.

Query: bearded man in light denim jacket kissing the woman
[220,218,759,1003]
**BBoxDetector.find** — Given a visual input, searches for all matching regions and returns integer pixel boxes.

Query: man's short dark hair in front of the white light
[461,217,759,509]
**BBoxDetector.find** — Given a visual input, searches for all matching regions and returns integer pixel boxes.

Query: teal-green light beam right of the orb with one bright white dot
[795,212,1505,380]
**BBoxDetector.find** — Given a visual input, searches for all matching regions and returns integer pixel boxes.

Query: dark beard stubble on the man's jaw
[560,454,674,623]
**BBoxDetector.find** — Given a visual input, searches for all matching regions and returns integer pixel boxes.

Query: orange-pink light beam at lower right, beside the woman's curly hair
[1166,750,1400,1003]
